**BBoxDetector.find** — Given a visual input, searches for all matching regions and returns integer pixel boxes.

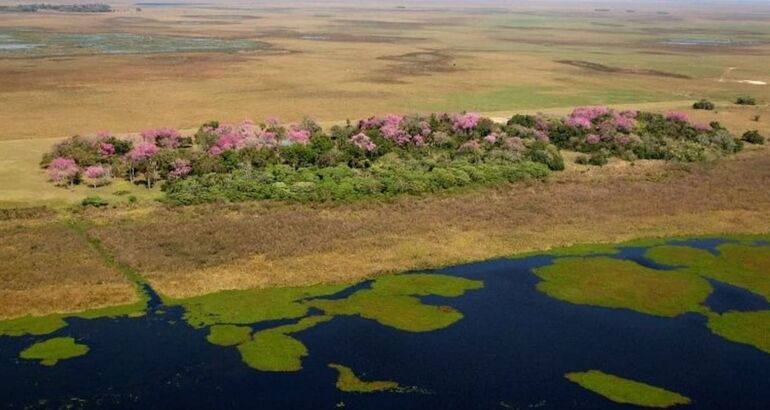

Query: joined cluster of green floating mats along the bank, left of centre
[172,273,483,372]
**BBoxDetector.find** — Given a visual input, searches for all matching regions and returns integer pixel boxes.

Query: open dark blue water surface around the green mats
[0,241,770,409]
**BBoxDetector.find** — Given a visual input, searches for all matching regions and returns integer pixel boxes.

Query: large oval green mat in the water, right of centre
[535,257,711,317]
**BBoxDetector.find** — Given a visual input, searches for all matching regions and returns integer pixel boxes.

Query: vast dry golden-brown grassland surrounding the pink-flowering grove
[0,0,770,317]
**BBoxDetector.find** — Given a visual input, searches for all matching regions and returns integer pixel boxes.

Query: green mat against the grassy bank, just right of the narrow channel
[169,285,351,328]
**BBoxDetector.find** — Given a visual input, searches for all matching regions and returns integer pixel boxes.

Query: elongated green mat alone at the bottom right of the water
[564,370,690,408]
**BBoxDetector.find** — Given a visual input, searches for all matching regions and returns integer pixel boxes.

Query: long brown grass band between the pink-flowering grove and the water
[91,150,770,297]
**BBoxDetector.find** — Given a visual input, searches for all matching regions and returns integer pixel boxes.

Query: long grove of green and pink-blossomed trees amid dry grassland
[42,107,756,204]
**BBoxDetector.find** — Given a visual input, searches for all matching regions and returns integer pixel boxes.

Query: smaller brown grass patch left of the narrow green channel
[0,221,137,319]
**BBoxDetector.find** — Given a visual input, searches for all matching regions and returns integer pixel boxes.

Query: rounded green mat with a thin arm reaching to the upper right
[238,316,332,372]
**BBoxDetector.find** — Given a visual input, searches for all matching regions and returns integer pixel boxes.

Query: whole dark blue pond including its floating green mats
[0,235,770,409]
